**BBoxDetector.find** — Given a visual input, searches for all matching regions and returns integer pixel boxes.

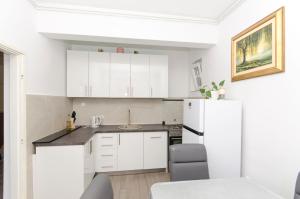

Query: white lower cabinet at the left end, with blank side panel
[33,140,95,199]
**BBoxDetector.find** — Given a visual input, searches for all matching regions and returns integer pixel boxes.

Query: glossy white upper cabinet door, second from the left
[89,52,110,97]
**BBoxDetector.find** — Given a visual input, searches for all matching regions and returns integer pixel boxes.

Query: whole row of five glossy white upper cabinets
[67,50,168,98]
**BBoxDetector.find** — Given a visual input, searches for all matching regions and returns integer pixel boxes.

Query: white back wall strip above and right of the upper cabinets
[70,45,190,98]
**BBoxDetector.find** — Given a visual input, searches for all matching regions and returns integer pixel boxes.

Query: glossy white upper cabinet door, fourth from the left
[131,55,150,97]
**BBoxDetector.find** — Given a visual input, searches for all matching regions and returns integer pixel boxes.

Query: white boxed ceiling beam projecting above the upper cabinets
[37,8,218,47]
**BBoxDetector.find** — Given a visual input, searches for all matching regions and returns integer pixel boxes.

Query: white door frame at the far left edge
[0,42,27,199]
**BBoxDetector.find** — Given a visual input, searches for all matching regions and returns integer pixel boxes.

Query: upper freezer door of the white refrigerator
[183,99,205,133]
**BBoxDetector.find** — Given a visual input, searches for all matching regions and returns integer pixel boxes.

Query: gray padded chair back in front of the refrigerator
[169,144,209,181]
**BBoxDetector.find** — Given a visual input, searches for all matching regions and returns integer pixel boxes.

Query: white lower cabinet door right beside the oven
[144,132,168,169]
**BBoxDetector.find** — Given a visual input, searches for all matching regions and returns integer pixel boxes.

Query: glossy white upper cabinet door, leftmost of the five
[67,51,89,97]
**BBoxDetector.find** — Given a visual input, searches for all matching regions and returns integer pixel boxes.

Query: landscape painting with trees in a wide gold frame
[231,7,285,81]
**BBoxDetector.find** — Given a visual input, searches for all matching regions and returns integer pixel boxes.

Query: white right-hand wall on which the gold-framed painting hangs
[192,0,300,198]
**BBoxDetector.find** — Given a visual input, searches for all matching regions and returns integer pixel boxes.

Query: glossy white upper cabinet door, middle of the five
[110,53,130,97]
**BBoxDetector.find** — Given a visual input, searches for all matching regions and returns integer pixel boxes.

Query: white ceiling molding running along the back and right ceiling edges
[28,0,245,25]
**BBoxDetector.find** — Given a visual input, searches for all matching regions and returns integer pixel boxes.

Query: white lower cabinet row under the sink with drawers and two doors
[94,132,168,172]
